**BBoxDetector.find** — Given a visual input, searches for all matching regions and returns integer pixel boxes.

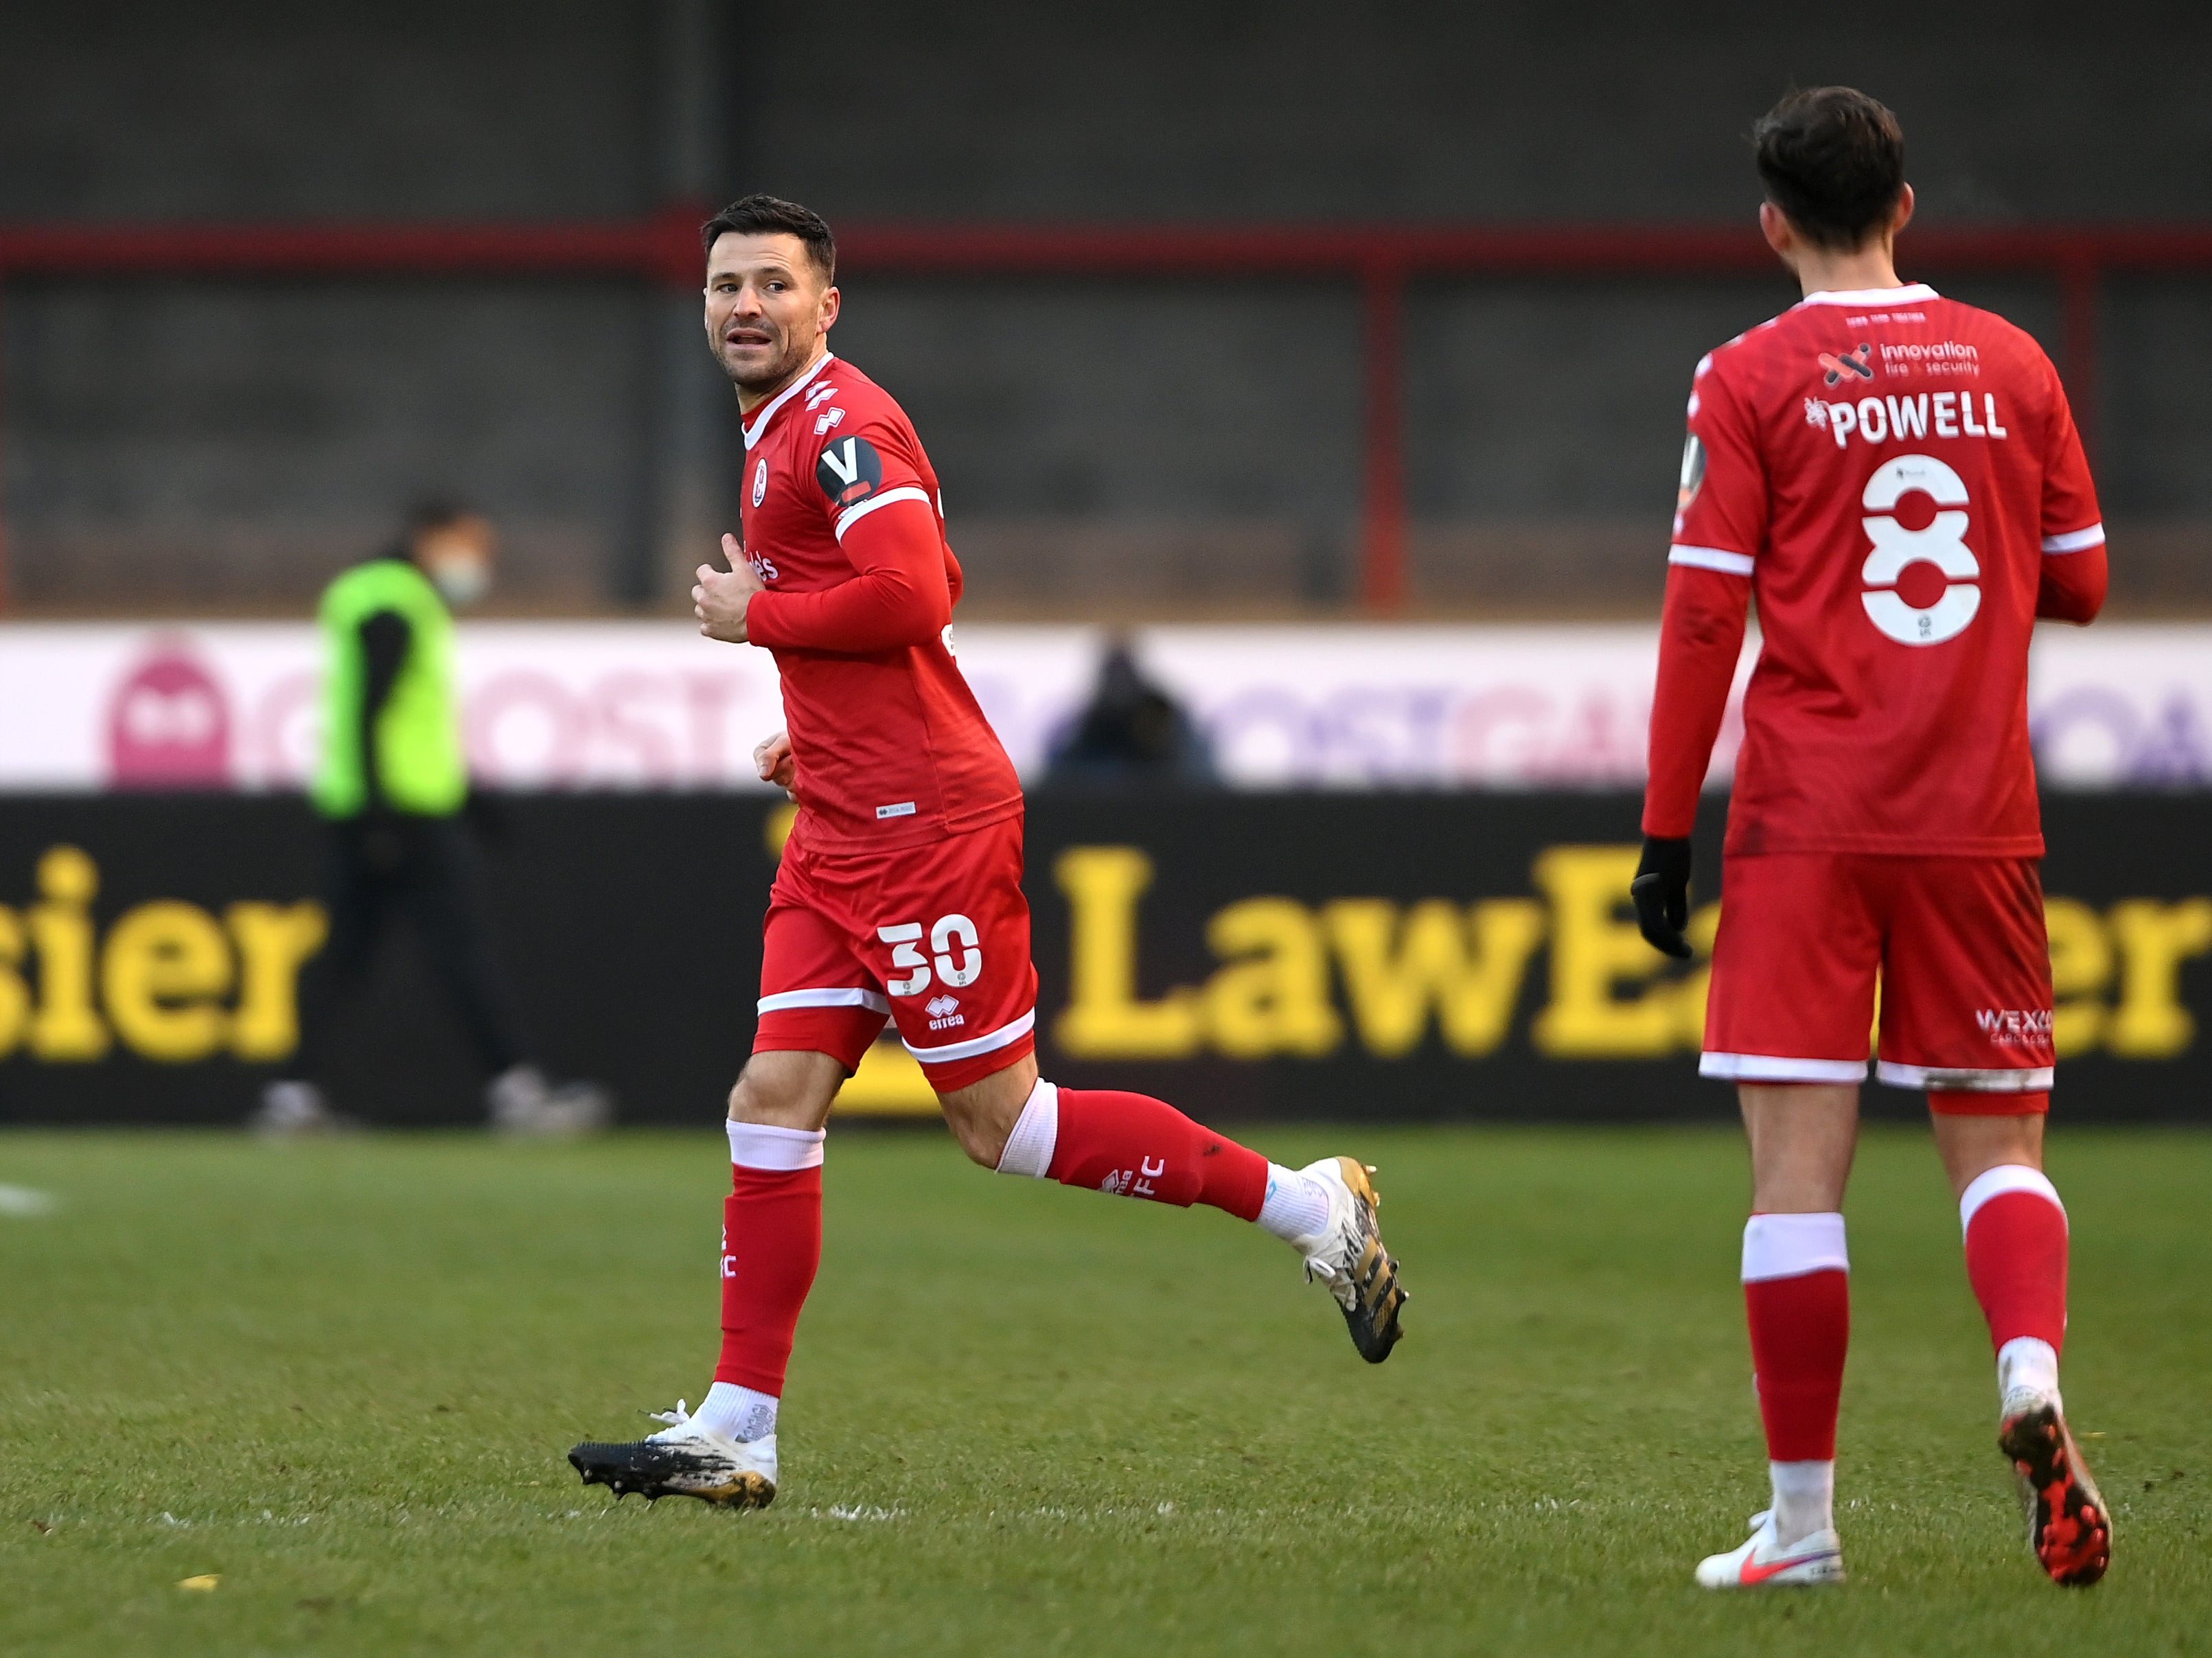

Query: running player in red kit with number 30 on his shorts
[568,194,1405,1508]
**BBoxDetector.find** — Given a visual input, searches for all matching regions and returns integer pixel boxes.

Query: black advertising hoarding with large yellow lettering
[0,794,2212,1125]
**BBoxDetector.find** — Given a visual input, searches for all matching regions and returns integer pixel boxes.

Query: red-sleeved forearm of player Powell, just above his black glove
[1644,564,1752,838]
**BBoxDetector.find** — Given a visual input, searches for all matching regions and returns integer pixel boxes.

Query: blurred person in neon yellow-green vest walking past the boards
[250,502,610,1134]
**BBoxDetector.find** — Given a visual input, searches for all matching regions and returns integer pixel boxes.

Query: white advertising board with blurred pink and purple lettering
[0,621,2212,792]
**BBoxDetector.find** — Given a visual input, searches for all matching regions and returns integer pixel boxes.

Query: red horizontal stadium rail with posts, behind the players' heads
[0,205,2212,614]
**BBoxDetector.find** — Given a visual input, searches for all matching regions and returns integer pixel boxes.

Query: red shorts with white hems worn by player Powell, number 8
[1698,853,2055,1112]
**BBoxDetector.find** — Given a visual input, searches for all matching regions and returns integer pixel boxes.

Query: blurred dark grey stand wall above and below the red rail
[0,0,2212,610]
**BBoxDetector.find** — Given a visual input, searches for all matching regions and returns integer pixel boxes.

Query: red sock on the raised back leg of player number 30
[1050,1087,1267,1220]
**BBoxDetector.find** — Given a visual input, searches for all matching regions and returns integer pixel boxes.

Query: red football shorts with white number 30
[752,818,1037,1094]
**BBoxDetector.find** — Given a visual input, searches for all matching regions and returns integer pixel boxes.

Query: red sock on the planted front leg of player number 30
[715,1163,823,1399]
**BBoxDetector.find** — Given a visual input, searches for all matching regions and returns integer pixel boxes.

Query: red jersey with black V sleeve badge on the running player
[741,356,1022,851]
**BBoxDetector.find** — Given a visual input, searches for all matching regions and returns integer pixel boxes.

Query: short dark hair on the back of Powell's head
[1752,87,1904,252]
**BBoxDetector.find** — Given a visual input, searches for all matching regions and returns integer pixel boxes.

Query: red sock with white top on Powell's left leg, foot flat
[1743,1214,1852,1461]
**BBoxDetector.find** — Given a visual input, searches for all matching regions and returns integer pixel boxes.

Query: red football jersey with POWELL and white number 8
[1668,285,2104,857]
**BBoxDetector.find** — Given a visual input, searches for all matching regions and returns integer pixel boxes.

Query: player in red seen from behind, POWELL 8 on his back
[1633,87,2112,1589]
